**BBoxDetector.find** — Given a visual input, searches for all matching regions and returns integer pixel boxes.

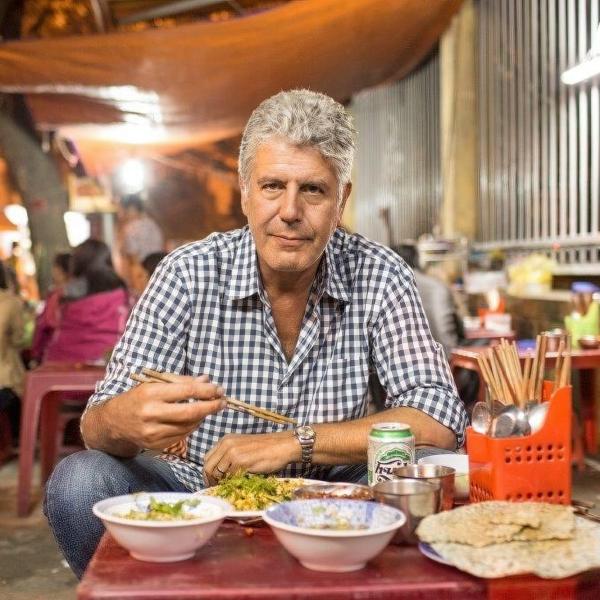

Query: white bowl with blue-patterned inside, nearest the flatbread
[263,498,406,573]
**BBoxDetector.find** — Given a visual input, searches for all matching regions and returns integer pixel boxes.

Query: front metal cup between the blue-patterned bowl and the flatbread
[373,479,442,544]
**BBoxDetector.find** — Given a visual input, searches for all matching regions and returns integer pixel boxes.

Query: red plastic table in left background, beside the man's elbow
[17,363,104,517]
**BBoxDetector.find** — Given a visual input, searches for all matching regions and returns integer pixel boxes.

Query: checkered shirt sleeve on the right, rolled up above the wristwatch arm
[372,271,468,447]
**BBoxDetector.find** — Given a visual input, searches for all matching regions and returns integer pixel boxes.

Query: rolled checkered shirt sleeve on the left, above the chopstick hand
[88,259,190,408]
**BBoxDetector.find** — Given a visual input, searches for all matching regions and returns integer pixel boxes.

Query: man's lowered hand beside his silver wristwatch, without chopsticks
[204,431,302,485]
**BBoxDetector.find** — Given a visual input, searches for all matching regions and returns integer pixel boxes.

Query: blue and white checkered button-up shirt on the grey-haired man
[89,227,467,490]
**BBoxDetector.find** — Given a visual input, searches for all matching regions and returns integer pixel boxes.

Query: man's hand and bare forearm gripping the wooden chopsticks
[82,376,225,455]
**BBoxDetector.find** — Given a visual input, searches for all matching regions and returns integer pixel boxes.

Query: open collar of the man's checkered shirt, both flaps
[227,226,351,302]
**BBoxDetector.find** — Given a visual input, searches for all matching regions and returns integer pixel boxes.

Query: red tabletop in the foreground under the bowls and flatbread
[77,523,600,600]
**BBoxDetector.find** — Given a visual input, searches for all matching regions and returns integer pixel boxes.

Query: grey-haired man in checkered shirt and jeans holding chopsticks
[46,90,466,575]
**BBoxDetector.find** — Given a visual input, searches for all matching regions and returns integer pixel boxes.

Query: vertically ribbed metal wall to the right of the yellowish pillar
[478,0,600,273]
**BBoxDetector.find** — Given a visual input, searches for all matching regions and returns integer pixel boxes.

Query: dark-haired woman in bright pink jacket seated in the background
[43,240,129,362]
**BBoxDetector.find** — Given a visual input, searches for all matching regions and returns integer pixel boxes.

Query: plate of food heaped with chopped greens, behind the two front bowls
[196,472,323,519]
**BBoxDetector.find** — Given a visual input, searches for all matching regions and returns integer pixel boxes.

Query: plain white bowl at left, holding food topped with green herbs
[93,492,231,562]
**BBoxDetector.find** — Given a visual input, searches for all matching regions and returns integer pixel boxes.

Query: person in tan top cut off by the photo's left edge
[0,262,25,443]
